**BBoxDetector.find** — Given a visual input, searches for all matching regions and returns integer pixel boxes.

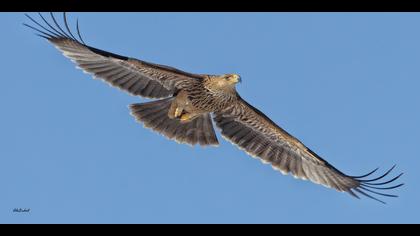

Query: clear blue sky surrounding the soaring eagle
[0,13,420,223]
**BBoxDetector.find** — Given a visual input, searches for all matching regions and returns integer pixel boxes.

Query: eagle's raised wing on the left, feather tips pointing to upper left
[24,13,203,98]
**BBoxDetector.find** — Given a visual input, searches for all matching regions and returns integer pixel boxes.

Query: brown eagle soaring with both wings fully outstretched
[24,13,403,203]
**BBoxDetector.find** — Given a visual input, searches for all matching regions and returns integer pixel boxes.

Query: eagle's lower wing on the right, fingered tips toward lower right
[214,96,403,202]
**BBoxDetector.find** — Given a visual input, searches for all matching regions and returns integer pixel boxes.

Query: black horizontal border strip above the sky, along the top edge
[1,0,420,12]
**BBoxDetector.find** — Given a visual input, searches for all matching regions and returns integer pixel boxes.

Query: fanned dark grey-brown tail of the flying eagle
[130,98,219,146]
